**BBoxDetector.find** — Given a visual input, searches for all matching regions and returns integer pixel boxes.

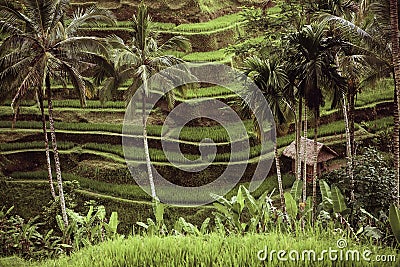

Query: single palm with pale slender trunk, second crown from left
[95,2,190,200]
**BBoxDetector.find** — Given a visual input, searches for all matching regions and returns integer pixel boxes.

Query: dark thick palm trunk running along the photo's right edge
[390,0,400,207]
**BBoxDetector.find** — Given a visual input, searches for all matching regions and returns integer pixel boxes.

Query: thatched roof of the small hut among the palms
[283,137,339,165]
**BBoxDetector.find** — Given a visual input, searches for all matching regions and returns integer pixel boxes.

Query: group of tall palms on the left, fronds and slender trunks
[0,0,189,228]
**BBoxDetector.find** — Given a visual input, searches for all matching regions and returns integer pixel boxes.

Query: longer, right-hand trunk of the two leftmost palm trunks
[46,75,68,226]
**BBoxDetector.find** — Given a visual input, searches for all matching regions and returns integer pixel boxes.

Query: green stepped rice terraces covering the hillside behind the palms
[0,0,393,232]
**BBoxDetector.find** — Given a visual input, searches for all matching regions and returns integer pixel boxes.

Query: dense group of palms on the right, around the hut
[244,0,400,225]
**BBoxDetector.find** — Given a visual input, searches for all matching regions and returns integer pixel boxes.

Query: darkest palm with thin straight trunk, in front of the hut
[289,22,345,225]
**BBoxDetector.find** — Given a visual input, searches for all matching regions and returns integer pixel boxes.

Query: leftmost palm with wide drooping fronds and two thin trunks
[0,0,114,225]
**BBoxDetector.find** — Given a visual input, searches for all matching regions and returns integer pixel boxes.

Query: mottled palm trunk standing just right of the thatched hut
[343,93,355,204]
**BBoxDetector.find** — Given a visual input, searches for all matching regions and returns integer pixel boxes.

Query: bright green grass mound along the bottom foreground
[26,229,398,267]
